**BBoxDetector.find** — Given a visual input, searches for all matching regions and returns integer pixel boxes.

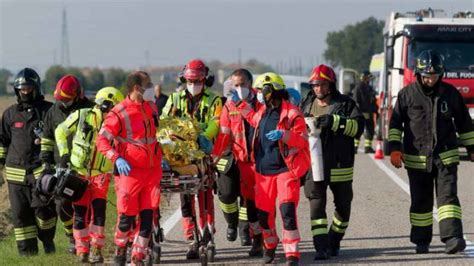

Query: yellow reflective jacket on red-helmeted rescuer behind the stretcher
[161,88,222,140]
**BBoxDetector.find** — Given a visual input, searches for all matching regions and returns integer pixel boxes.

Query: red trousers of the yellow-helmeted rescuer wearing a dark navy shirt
[255,172,300,257]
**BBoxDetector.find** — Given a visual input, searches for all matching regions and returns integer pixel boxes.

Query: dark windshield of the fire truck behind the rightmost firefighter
[407,41,474,71]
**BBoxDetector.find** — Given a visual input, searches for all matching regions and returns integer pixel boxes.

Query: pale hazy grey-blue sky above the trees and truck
[0,0,474,75]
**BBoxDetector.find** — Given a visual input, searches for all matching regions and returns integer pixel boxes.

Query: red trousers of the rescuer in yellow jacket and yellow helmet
[73,174,111,254]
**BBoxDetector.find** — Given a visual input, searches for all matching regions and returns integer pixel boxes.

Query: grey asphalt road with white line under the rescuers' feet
[156,153,474,265]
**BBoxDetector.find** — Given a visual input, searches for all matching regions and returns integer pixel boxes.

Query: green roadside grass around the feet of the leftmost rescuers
[0,182,117,266]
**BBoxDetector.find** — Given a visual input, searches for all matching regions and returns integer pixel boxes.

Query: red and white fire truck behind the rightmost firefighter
[378,8,474,152]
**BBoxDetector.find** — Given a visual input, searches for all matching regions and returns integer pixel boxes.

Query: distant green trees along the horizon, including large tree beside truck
[0,17,384,95]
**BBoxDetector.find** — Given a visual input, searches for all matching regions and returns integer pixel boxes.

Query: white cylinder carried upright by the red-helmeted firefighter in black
[305,117,324,182]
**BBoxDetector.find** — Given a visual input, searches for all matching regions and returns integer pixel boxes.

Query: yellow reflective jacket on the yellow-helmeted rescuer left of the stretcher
[54,107,112,176]
